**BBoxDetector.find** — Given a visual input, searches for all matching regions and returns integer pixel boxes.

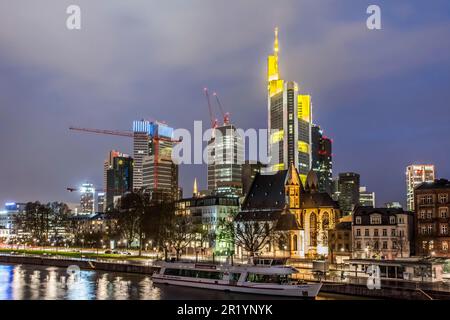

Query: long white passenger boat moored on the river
[152,259,322,298]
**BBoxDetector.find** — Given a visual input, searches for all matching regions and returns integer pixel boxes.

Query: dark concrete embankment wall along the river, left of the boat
[0,255,159,275]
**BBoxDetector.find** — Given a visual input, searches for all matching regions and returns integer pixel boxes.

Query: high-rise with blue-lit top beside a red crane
[133,120,179,199]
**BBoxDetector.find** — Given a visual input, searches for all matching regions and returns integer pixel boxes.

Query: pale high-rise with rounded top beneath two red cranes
[207,123,244,195]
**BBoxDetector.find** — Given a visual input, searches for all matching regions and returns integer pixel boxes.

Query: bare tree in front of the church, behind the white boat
[234,221,275,257]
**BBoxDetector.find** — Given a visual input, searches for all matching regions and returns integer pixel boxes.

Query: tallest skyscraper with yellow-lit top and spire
[267,28,312,182]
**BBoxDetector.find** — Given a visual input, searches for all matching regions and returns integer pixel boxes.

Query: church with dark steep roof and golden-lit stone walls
[235,164,341,258]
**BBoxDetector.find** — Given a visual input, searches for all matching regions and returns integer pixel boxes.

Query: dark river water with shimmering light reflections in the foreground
[0,264,355,300]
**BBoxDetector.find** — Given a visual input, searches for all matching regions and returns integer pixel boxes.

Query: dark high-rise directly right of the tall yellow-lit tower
[311,125,333,195]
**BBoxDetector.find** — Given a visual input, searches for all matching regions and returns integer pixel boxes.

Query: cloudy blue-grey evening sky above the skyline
[0,0,450,205]
